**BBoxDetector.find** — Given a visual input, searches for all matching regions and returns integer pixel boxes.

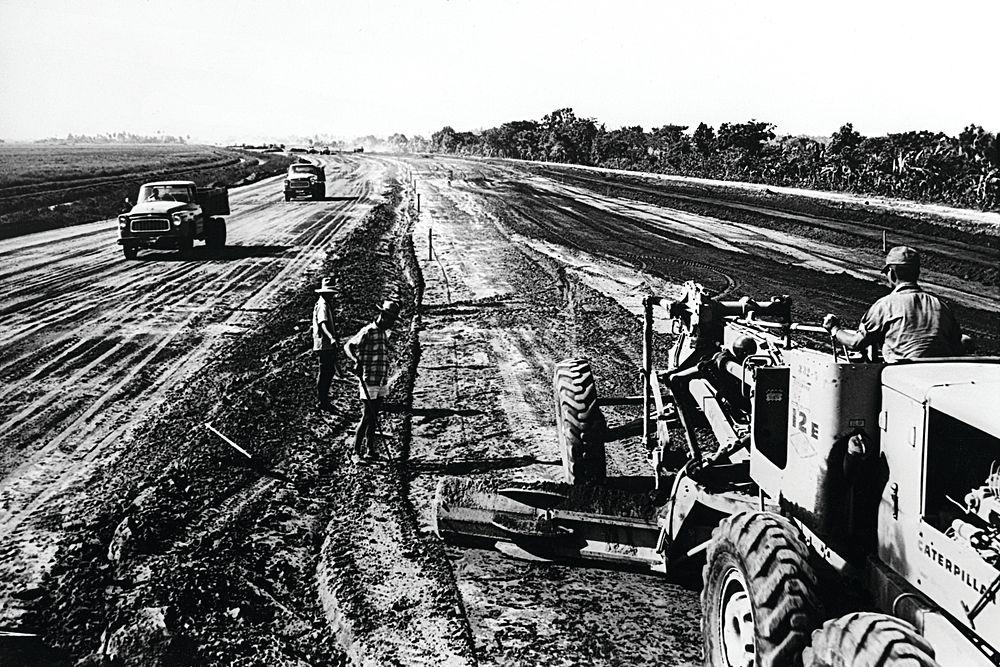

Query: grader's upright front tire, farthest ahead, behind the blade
[553,359,607,484]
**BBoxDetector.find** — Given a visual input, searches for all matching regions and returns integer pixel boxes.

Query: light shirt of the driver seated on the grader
[858,283,962,363]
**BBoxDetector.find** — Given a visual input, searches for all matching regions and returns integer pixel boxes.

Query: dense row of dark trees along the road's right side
[387,108,1000,209]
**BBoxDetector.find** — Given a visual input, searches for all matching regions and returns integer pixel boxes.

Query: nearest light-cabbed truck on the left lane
[118,181,229,259]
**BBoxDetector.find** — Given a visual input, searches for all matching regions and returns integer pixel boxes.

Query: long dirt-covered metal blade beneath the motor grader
[434,477,663,569]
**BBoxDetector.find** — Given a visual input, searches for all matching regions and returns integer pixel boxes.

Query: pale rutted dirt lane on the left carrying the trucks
[0,158,385,627]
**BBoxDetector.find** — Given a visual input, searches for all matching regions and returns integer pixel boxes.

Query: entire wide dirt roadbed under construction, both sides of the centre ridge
[0,155,1000,665]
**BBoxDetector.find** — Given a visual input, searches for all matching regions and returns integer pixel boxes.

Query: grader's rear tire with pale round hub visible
[701,512,822,667]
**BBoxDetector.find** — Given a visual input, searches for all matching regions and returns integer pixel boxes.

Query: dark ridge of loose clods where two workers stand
[13,179,468,665]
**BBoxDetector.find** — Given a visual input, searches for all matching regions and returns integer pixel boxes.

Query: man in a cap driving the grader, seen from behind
[823,246,962,363]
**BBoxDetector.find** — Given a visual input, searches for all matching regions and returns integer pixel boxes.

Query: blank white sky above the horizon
[0,0,1000,141]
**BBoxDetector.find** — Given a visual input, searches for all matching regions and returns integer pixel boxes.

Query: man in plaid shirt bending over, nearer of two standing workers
[344,301,399,459]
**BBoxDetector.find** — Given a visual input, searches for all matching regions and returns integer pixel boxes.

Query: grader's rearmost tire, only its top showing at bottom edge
[802,612,938,667]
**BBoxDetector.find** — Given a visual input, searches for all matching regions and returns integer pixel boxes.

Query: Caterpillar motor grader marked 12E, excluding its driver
[435,283,1000,667]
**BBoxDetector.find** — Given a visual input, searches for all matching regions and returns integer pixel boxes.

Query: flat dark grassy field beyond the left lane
[0,144,294,238]
